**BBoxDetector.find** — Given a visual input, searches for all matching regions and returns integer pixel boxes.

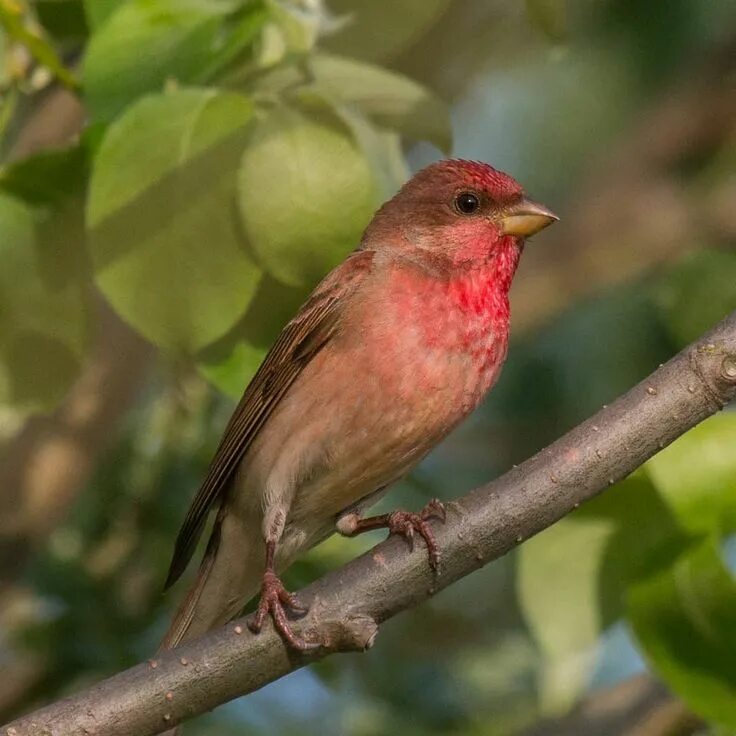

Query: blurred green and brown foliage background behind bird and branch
[0,0,736,736]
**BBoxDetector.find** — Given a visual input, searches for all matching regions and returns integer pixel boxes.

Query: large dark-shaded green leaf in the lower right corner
[628,540,736,728]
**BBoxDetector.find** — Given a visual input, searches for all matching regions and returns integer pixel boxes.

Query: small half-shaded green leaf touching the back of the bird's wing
[197,276,308,399]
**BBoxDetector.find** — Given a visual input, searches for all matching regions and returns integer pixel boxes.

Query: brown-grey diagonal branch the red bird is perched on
[2,312,736,736]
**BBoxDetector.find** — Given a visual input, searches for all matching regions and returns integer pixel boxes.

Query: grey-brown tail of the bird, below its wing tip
[160,514,265,650]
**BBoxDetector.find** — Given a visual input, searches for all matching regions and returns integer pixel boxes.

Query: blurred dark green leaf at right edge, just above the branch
[654,250,736,345]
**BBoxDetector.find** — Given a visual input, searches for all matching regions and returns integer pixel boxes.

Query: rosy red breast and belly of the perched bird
[243,258,508,534]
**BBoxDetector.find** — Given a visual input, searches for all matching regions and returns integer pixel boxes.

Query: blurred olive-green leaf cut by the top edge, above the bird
[322,0,452,61]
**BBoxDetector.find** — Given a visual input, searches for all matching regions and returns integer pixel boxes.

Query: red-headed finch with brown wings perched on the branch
[161,159,558,651]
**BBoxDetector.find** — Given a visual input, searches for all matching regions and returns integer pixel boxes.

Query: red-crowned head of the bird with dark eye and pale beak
[363,159,558,265]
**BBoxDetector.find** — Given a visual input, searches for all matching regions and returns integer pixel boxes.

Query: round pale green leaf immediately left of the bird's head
[238,107,379,286]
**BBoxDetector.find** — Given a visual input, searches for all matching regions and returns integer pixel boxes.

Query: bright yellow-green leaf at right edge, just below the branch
[645,412,736,534]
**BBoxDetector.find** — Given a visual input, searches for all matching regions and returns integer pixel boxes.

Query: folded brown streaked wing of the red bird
[165,250,373,588]
